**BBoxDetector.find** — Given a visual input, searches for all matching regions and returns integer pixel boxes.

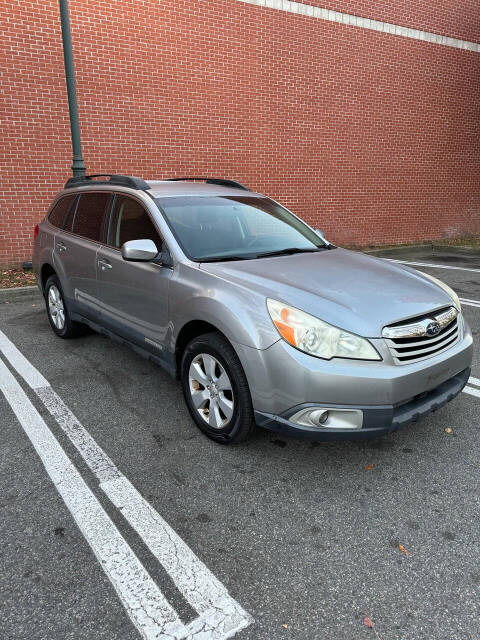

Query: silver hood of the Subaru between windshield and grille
[201,249,458,338]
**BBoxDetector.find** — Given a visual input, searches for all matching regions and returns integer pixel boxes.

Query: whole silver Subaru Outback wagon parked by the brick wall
[33,175,472,443]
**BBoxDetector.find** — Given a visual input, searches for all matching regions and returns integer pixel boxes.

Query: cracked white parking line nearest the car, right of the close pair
[0,331,253,640]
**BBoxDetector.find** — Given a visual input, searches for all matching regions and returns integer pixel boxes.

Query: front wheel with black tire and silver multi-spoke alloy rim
[180,333,255,444]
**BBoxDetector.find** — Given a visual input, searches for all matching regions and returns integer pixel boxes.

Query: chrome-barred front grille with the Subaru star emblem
[383,307,460,364]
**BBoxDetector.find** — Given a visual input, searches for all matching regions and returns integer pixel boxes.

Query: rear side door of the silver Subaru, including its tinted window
[54,191,113,319]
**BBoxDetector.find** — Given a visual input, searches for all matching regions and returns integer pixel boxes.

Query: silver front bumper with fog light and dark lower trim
[234,324,473,440]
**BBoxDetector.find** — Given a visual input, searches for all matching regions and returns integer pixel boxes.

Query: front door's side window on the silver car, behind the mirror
[107,196,162,251]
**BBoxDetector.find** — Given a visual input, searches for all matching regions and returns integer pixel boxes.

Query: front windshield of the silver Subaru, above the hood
[155,196,326,262]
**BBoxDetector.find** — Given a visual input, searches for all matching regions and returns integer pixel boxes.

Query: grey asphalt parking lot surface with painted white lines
[0,248,480,640]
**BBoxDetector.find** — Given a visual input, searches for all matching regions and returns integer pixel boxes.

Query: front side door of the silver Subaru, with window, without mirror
[97,194,172,357]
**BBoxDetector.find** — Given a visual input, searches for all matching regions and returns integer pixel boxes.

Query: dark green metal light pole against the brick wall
[59,0,85,177]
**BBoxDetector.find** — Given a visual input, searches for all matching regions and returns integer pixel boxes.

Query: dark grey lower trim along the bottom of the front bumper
[255,368,471,441]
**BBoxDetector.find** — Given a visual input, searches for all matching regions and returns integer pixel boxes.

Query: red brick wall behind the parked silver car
[0,0,480,264]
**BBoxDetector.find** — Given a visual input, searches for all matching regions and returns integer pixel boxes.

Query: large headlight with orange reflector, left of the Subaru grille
[267,298,381,360]
